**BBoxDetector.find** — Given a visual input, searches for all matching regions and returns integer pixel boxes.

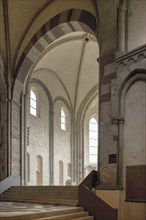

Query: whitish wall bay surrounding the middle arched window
[54,100,71,185]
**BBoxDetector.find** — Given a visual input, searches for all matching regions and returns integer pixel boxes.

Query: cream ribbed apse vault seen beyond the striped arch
[31,32,99,109]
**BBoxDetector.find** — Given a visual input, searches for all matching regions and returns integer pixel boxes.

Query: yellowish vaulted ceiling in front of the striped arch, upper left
[0,0,98,70]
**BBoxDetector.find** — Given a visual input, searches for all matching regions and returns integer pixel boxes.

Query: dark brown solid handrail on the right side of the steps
[78,170,118,220]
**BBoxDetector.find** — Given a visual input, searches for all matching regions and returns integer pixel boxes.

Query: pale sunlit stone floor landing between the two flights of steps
[0,202,77,217]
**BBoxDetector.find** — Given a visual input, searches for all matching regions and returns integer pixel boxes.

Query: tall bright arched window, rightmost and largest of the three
[89,117,98,164]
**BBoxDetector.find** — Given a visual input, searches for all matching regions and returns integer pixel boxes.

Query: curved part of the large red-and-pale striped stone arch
[14,9,98,94]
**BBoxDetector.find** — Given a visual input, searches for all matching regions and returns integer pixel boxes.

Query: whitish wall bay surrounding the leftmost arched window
[27,84,49,185]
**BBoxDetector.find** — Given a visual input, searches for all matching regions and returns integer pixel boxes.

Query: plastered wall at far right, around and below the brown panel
[119,80,146,220]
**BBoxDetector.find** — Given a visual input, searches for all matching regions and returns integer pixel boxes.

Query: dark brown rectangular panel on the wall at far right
[126,165,146,202]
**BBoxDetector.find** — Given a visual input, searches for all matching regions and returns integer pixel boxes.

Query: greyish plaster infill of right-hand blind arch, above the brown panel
[123,80,146,166]
